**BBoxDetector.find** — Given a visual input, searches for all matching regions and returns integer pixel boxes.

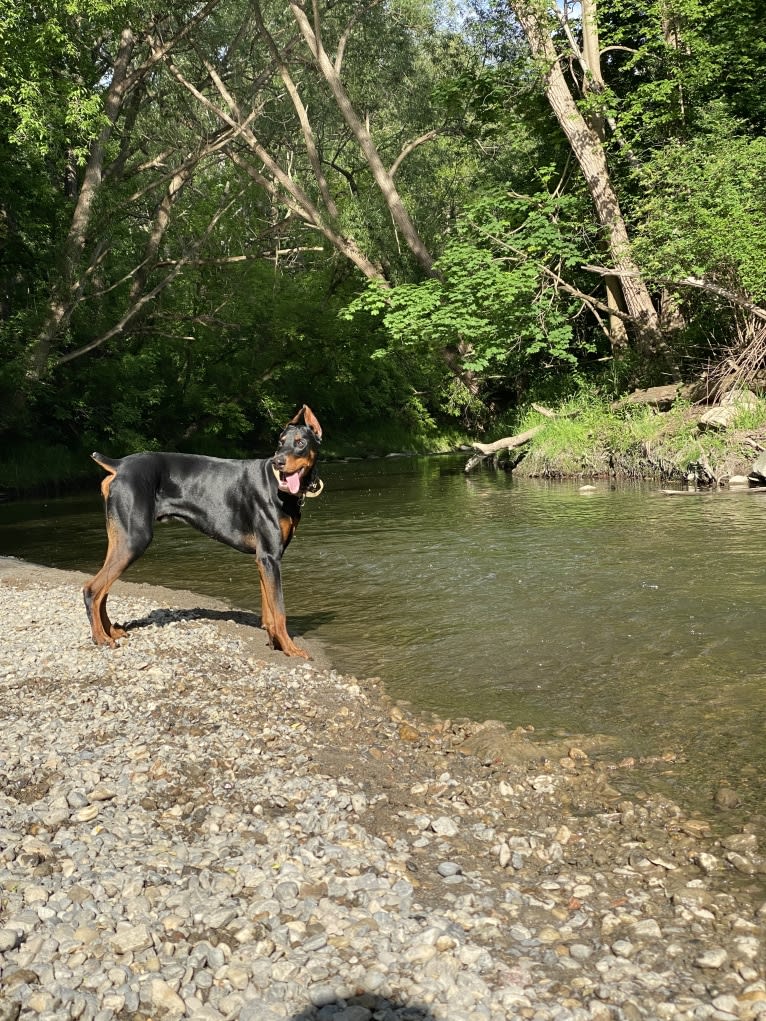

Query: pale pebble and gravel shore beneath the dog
[0,561,766,1021]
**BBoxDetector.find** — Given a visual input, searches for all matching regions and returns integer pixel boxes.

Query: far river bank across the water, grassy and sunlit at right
[6,394,766,501]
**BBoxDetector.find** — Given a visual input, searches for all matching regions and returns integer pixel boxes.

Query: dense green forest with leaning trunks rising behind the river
[0,0,766,484]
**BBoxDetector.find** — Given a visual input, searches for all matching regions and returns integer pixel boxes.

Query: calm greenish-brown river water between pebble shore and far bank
[0,457,766,813]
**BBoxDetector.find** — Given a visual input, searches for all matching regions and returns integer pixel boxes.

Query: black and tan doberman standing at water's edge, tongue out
[83,404,322,659]
